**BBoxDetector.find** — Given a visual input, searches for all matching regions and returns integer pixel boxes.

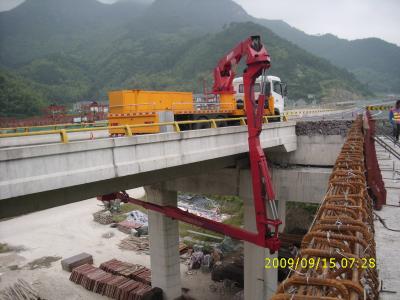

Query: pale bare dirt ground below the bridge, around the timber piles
[0,189,238,300]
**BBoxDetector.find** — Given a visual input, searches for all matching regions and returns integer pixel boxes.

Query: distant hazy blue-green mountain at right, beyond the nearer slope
[257,19,400,93]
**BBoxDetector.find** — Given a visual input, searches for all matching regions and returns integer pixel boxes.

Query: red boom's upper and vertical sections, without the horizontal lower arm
[213,36,282,251]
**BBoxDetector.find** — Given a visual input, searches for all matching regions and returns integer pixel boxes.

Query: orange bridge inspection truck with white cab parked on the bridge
[108,36,286,135]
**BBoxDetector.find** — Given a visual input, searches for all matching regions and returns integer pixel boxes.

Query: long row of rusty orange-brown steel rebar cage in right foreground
[272,117,379,300]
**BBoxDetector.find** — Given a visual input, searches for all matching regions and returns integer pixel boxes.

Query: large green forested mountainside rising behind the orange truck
[0,0,371,116]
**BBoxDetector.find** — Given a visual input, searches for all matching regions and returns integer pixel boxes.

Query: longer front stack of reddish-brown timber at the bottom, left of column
[70,264,162,300]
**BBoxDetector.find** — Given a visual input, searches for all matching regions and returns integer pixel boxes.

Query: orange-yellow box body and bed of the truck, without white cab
[108,90,274,135]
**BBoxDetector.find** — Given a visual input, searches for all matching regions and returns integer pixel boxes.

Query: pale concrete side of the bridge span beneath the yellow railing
[0,122,297,217]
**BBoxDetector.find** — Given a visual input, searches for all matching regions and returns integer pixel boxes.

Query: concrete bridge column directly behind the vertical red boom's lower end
[239,170,278,300]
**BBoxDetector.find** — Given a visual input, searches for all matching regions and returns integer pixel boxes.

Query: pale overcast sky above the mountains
[0,0,400,45]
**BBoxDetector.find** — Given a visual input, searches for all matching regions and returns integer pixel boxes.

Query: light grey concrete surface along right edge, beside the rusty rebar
[374,138,400,300]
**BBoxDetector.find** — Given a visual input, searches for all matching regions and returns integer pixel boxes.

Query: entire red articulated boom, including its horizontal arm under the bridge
[98,36,282,253]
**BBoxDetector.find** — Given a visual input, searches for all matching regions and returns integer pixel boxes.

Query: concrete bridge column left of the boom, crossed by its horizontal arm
[145,186,182,300]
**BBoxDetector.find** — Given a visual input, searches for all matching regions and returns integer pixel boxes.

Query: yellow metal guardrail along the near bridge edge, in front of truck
[0,115,288,144]
